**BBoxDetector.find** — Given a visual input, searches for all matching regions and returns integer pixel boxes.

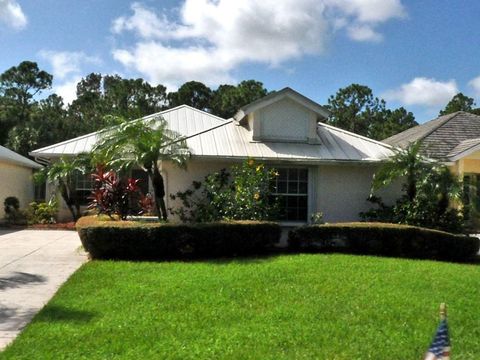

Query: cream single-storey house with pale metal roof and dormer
[31,88,398,224]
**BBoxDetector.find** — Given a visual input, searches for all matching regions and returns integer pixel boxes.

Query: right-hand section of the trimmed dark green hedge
[288,223,480,261]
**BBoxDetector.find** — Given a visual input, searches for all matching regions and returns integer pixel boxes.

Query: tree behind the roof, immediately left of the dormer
[211,80,268,119]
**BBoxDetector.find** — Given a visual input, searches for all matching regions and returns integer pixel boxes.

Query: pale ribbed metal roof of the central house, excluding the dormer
[31,102,393,162]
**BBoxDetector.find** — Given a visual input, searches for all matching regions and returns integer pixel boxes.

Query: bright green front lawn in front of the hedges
[0,255,480,360]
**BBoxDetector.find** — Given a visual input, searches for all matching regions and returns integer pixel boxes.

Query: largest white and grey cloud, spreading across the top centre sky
[112,0,405,86]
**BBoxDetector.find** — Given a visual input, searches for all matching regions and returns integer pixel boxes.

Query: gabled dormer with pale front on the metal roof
[234,88,329,144]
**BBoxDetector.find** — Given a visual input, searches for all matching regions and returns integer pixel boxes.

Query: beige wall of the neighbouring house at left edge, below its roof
[0,161,34,219]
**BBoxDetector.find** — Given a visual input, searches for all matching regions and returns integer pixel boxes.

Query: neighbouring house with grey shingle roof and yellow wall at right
[383,111,480,224]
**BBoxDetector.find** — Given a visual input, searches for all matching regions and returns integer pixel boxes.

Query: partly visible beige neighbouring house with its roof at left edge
[0,146,42,220]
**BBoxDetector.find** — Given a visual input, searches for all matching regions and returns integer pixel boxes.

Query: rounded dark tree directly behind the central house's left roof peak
[168,81,212,111]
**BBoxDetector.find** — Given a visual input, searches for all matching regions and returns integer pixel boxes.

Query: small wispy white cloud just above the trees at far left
[38,50,101,104]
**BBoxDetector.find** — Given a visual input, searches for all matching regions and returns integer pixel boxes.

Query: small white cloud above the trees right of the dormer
[384,77,458,107]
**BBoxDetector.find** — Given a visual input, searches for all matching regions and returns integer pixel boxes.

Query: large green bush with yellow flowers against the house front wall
[170,159,278,222]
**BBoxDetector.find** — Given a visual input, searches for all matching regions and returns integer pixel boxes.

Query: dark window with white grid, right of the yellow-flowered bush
[274,168,308,221]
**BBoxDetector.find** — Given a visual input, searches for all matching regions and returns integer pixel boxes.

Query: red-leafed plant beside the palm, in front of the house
[88,166,140,220]
